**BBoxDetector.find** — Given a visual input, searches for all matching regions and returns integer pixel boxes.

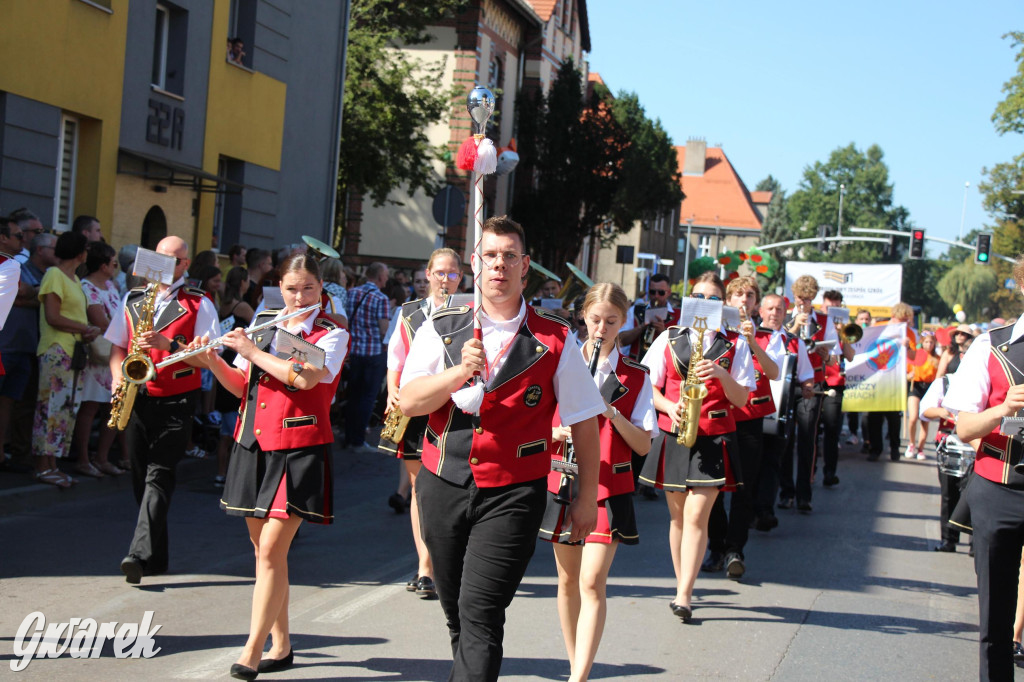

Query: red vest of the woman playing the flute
[234,310,341,452]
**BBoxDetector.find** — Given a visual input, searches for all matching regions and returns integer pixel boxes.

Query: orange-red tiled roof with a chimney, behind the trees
[676,146,770,229]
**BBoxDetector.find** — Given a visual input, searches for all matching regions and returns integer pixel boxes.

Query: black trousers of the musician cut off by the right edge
[966,476,1024,682]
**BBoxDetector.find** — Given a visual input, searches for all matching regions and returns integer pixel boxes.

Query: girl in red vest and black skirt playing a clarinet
[541,284,657,681]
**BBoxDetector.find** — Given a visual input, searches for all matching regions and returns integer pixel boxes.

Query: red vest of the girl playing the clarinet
[548,354,647,502]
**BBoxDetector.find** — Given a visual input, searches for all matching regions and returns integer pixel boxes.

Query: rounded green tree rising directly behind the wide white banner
[786,142,910,263]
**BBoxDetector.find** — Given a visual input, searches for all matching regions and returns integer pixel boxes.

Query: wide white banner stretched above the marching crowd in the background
[785,260,903,309]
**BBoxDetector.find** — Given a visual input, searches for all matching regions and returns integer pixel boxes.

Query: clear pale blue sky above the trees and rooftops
[587,0,1024,255]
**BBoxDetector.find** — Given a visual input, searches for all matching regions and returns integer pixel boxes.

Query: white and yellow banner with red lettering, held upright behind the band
[843,325,906,412]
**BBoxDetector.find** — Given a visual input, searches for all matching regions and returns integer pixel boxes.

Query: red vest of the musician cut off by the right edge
[974,325,1024,487]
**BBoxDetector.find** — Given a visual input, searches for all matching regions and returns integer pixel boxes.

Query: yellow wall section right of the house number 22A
[196,0,288,245]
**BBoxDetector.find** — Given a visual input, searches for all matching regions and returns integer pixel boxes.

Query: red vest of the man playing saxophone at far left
[125,286,206,397]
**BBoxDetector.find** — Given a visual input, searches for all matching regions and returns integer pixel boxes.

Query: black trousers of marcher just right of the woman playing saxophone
[708,418,770,558]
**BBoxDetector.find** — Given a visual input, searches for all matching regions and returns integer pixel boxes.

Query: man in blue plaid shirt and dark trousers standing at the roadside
[345,263,391,449]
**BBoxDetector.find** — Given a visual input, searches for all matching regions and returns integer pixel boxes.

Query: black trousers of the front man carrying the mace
[416,469,547,682]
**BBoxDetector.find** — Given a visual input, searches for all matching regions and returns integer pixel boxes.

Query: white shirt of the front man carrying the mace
[399,301,605,426]
